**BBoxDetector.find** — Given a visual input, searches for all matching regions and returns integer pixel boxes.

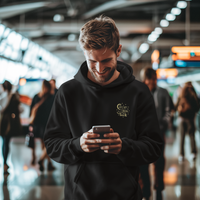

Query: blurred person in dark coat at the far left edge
[0,81,22,174]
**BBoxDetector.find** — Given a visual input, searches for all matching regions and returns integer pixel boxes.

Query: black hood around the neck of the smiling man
[74,61,135,88]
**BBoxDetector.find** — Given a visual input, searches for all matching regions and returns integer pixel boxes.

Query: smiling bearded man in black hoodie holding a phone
[44,16,163,200]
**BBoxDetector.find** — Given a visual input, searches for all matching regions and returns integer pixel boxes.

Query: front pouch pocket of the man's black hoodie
[70,163,138,200]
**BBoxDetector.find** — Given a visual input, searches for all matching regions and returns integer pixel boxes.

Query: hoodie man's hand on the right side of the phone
[97,130,122,155]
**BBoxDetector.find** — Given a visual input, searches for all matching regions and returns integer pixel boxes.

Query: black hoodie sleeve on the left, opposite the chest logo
[44,88,84,164]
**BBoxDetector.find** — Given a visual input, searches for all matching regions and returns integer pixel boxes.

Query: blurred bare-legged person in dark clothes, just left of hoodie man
[29,80,55,171]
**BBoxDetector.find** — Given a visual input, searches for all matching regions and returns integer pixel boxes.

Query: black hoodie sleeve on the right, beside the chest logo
[118,90,163,166]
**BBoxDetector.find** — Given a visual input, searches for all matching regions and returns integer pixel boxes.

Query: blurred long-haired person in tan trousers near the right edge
[175,82,199,162]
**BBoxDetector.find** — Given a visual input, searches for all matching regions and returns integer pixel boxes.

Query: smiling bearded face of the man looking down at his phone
[84,45,121,85]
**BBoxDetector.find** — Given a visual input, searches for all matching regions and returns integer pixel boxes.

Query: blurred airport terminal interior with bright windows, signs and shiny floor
[0,0,200,200]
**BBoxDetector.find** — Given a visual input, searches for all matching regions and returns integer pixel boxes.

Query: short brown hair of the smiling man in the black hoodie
[79,15,119,52]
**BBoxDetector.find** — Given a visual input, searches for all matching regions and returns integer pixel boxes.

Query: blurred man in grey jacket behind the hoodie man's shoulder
[140,68,174,200]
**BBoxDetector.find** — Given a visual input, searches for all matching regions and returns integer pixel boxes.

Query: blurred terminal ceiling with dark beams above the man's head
[0,0,200,68]
